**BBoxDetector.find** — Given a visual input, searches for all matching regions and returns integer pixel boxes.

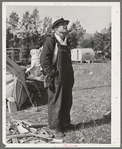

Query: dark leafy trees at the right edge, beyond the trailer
[80,24,111,60]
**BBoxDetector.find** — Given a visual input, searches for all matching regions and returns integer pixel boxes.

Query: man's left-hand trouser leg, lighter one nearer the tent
[48,83,62,130]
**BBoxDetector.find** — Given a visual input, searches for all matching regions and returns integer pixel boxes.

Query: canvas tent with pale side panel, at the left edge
[6,57,33,110]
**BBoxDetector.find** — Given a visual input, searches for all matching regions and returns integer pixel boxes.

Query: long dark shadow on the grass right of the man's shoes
[76,115,111,129]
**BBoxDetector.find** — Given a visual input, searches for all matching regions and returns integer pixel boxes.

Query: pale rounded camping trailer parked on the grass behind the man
[71,48,95,62]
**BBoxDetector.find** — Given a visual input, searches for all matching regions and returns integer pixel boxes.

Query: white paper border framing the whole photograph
[2,2,121,148]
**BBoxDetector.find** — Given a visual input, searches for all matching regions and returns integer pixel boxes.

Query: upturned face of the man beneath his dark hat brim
[55,22,67,33]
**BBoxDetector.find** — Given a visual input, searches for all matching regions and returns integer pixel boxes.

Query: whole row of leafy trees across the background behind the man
[6,8,111,62]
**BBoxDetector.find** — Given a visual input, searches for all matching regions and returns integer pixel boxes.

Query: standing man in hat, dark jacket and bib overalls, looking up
[41,17,74,138]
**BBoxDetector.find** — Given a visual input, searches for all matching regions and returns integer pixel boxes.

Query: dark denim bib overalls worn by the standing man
[48,44,74,130]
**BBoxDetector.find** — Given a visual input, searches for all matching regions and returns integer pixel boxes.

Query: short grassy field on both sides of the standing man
[6,61,111,144]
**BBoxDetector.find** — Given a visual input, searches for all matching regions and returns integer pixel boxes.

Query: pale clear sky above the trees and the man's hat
[6,5,111,34]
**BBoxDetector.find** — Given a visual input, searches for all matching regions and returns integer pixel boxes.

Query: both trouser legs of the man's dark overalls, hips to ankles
[48,69,74,129]
